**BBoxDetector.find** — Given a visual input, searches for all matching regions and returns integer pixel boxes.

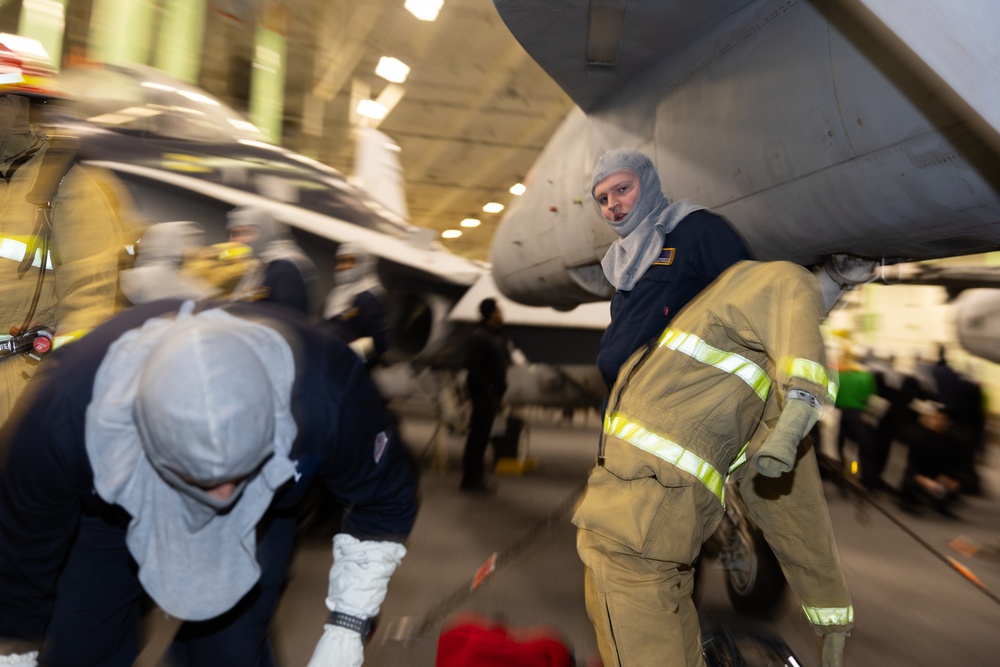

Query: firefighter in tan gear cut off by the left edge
[0,54,124,424]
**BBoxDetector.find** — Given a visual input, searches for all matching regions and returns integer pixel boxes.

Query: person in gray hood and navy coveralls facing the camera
[591,148,753,388]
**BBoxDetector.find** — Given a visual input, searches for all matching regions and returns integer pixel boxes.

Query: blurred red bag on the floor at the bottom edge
[434,616,576,667]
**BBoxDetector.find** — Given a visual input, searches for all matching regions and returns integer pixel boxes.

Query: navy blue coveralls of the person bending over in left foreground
[0,301,417,667]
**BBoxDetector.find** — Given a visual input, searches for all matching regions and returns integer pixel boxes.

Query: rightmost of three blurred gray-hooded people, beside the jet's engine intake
[323,243,390,366]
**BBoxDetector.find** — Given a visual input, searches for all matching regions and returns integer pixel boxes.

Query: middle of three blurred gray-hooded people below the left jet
[226,206,316,315]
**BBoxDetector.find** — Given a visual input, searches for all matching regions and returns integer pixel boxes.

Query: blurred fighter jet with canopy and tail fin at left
[45,64,606,406]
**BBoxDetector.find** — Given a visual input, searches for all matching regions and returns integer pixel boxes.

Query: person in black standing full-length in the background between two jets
[460,299,511,493]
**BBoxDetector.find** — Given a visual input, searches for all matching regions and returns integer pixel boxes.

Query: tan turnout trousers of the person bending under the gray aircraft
[574,468,722,667]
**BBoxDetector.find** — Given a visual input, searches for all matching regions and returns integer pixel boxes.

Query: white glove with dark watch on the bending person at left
[308,533,406,667]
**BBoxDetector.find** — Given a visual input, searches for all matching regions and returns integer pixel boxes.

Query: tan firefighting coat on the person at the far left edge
[0,118,126,423]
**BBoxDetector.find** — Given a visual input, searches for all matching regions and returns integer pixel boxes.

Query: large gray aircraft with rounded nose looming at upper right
[491,0,1000,318]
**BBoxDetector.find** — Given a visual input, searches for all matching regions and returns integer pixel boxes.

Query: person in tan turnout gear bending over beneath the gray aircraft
[573,262,854,667]
